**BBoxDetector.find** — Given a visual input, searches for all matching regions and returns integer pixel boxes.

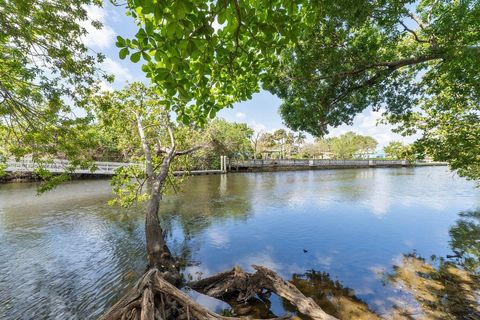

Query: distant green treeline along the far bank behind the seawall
[82,119,415,169]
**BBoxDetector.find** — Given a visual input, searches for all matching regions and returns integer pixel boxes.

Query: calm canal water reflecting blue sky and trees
[0,167,480,319]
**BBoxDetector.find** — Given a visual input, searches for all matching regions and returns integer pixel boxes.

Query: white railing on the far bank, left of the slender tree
[5,159,131,175]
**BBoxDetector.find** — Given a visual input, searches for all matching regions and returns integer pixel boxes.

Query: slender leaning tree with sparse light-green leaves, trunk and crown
[91,83,200,282]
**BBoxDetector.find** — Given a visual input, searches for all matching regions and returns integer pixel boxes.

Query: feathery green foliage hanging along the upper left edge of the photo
[0,0,109,191]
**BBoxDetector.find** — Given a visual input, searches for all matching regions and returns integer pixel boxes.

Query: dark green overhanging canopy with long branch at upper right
[267,0,480,179]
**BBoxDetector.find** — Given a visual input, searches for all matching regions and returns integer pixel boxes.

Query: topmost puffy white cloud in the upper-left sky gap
[80,6,115,49]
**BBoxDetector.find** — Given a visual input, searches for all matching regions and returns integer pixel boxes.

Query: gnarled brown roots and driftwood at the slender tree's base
[100,266,336,320]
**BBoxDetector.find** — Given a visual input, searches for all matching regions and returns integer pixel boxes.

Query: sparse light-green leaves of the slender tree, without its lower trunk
[88,82,200,207]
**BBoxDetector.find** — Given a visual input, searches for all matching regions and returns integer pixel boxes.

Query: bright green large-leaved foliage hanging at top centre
[116,0,318,124]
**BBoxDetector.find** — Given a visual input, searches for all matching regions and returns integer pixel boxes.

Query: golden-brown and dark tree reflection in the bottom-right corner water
[388,211,480,319]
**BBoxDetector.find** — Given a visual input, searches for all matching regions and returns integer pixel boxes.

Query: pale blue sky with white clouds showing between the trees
[83,1,414,151]
